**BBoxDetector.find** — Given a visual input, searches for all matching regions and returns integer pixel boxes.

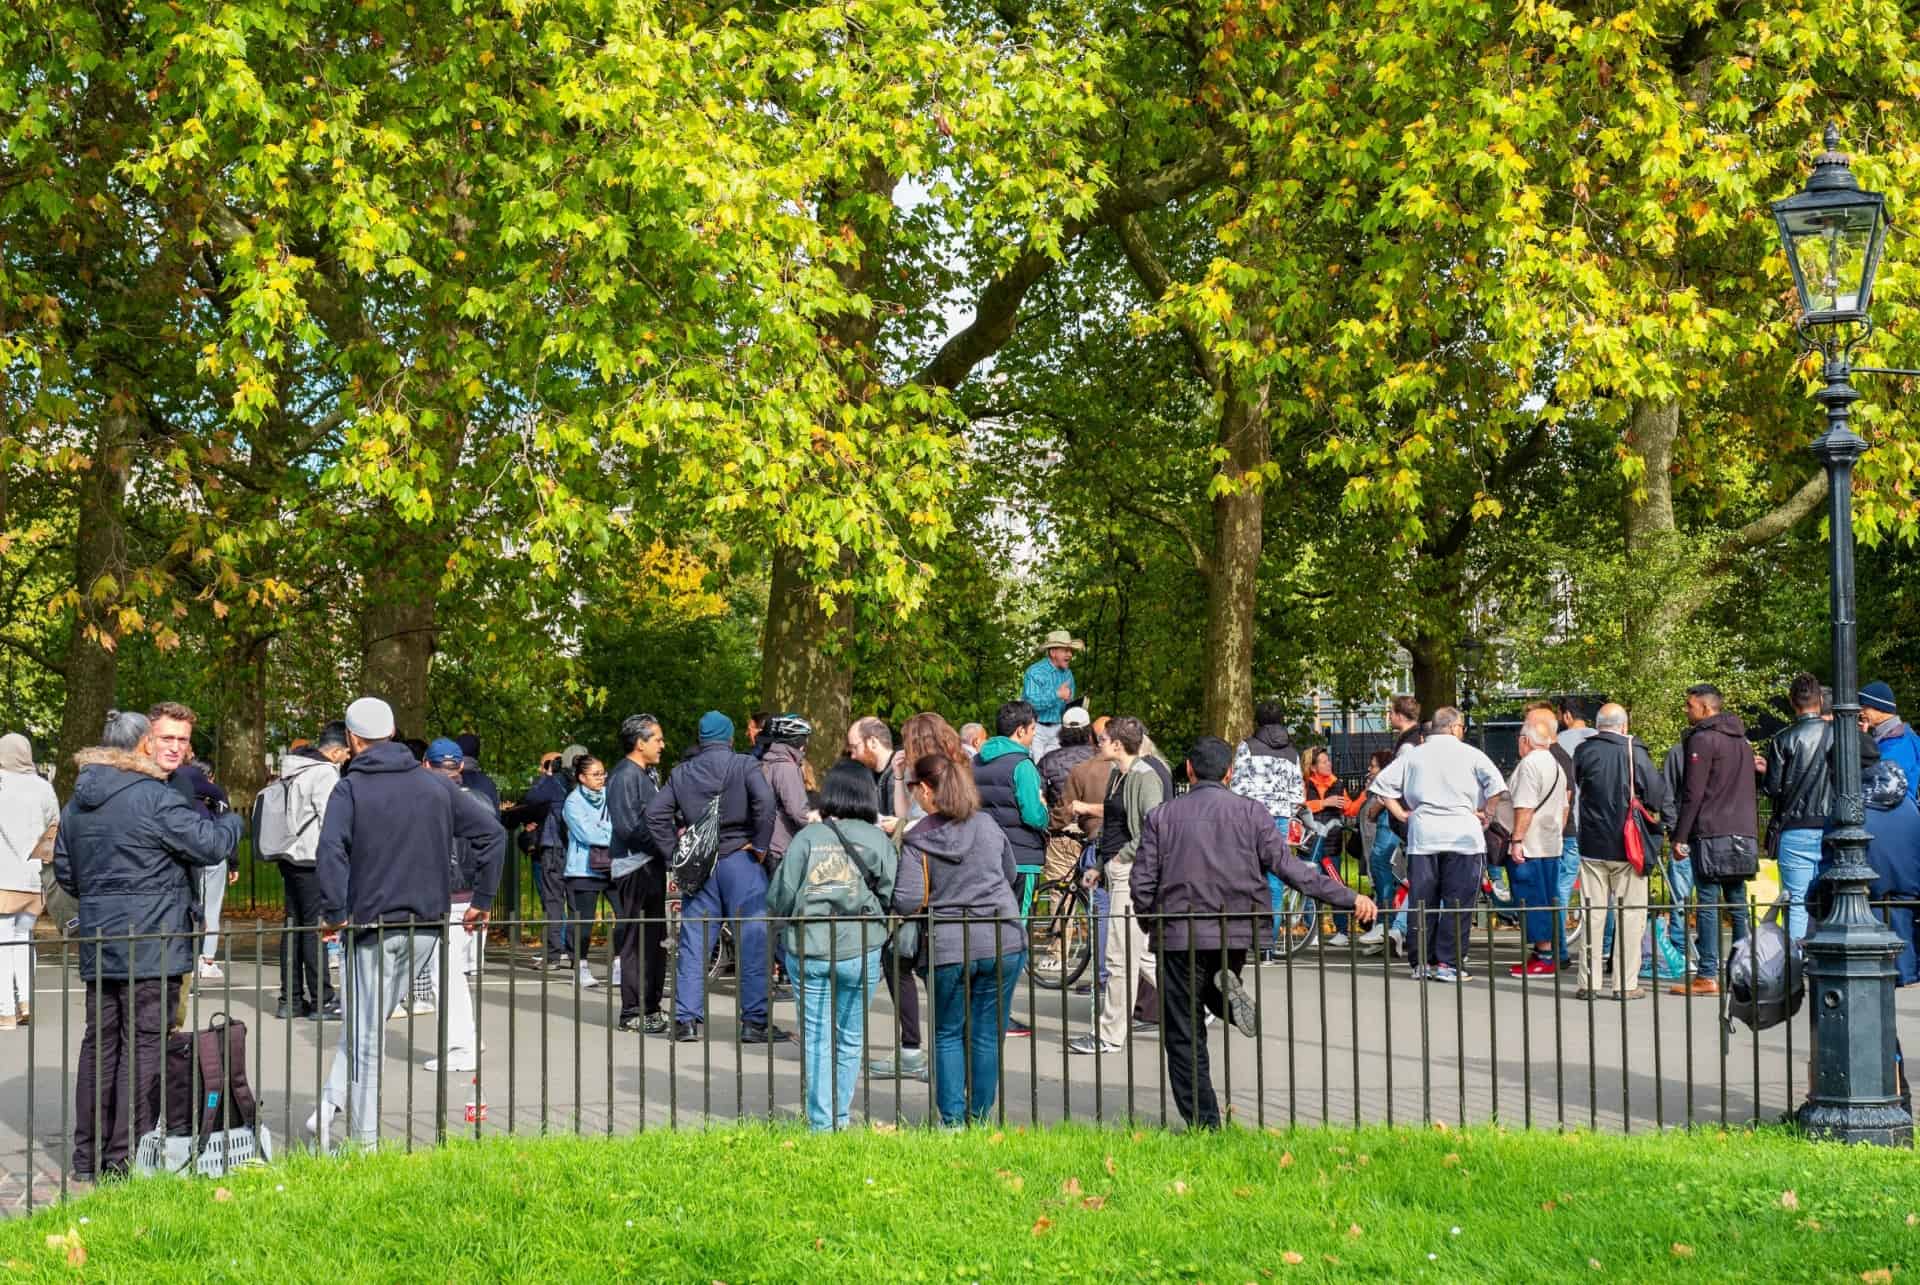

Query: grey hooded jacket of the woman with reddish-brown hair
[893,811,1027,968]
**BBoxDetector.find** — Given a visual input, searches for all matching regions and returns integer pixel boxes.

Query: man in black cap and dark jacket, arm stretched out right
[1131,736,1375,1129]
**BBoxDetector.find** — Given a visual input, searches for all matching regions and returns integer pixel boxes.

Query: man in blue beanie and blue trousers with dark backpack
[647,709,789,1045]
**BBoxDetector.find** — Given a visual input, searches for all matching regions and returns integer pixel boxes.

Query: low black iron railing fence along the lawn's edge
[0,889,1920,1210]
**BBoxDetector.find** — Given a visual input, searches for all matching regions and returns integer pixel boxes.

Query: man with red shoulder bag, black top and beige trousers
[1572,703,1665,1001]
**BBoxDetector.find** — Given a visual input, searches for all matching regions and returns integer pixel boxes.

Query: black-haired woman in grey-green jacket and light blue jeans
[766,759,899,1131]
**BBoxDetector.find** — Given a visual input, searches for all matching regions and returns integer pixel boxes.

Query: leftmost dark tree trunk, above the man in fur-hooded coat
[56,415,134,803]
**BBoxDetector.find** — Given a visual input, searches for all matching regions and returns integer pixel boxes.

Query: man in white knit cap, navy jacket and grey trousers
[307,695,507,1147]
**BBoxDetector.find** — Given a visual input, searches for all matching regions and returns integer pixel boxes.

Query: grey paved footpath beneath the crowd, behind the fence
[0,933,1920,1212]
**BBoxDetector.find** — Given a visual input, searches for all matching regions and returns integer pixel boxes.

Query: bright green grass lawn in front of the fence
[0,1127,1920,1283]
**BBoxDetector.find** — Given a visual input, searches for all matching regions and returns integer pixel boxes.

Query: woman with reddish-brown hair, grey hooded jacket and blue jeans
[893,755,1027,1127]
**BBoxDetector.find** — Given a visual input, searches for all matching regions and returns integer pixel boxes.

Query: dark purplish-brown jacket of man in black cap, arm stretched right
[1131,782,1356,952]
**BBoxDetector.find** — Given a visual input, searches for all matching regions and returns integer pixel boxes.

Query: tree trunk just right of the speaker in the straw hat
[1200,380,1273,743]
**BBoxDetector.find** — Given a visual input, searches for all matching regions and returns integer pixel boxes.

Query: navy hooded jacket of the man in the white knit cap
[317,741,507,928]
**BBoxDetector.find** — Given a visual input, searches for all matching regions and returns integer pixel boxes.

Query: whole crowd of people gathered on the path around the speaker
[0,632,1920,1179]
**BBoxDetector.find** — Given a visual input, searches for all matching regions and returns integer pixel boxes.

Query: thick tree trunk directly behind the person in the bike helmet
[760,547,852,772]
